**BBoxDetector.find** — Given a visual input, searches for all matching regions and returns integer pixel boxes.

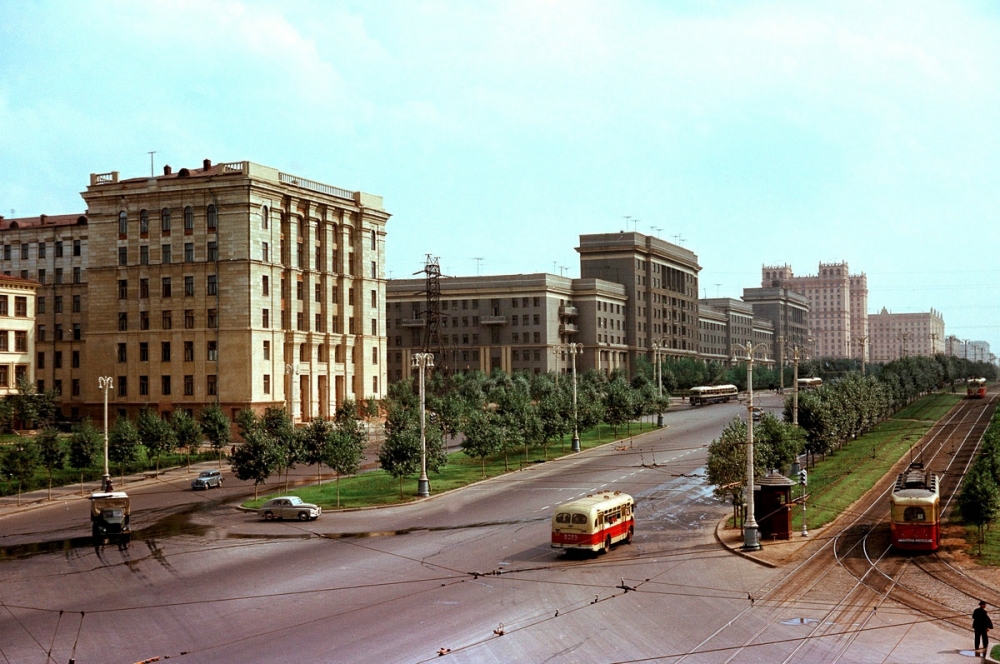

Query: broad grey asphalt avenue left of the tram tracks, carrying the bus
[0,397,968,663]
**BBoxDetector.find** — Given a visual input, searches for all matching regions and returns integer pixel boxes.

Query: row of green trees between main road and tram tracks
[708,355,988,528]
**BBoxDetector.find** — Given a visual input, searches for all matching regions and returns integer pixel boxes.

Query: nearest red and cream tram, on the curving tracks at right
[889,463,941,551]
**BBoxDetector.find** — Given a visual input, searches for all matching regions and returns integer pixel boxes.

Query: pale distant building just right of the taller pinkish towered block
[868,307,945,362]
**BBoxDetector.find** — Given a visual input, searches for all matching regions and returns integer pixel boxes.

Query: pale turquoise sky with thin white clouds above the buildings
[0,0,1000,354]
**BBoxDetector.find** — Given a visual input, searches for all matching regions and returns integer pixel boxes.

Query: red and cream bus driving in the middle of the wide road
[552,491,635,553]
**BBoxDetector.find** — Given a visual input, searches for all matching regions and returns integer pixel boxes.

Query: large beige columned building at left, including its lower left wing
[0,160,389,421]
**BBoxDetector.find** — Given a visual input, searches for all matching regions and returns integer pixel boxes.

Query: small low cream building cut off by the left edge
[0,275,38,397]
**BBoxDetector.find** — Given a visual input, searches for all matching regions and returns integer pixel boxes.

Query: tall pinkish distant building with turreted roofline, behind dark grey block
[761,261,868,359]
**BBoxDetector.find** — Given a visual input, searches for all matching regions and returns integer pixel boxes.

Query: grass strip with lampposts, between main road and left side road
[243,422,657,509]
